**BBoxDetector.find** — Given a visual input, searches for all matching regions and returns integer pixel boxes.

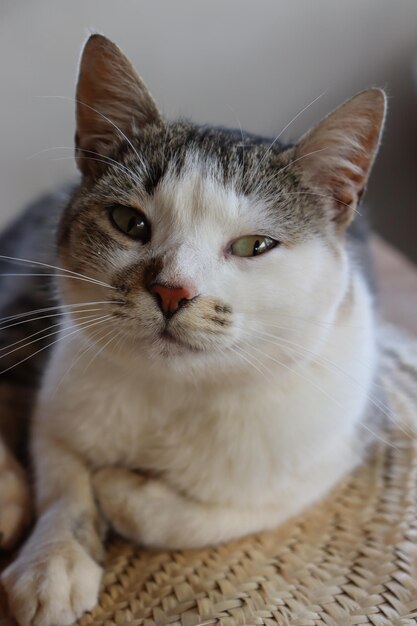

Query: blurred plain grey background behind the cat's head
[0,0,417,261]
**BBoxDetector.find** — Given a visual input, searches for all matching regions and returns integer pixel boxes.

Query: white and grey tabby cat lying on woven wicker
[0,35,386,626]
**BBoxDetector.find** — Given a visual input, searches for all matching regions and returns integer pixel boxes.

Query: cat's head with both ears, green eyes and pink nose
[58,35,385,375]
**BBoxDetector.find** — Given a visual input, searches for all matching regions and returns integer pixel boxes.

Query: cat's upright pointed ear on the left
[75,35,162,174]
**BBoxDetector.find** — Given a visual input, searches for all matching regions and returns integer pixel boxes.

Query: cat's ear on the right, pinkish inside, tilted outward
[295,89,386,231]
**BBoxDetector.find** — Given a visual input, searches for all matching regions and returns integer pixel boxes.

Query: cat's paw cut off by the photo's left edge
[0,457,32,550]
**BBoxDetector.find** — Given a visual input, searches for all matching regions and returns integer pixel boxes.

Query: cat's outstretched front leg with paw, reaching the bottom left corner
[1,438,103,626]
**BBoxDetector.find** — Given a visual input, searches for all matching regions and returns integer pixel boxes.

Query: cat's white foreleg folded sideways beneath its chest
[93,468,282,549]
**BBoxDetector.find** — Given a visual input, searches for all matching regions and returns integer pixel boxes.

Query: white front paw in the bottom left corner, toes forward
[1,539,102,626]
